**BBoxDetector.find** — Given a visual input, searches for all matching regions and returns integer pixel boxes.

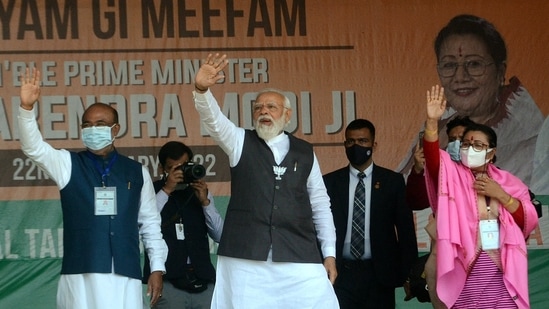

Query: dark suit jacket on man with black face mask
[324,164,418,287]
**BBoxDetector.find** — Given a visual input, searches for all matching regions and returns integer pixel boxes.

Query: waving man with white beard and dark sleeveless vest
[193,54,339,309]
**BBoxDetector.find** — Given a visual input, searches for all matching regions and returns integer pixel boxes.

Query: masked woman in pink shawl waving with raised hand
[424,85,538,308]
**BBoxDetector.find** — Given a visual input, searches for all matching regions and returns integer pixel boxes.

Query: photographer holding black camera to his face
[143,141,223,308]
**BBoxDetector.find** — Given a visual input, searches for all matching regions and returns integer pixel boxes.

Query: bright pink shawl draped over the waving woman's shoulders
[425,150,538,308]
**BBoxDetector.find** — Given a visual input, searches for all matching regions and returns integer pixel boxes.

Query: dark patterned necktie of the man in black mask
[351,173,366,259]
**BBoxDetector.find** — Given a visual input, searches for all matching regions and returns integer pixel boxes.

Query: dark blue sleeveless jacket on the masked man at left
[60,151,143,280]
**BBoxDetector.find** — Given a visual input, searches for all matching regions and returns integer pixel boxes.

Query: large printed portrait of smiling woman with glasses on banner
[398,15,549,195]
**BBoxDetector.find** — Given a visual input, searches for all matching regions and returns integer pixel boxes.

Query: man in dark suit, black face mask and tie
[324,119,417,309]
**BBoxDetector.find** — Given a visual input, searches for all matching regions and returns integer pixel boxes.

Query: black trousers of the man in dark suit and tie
[334,260,396,309]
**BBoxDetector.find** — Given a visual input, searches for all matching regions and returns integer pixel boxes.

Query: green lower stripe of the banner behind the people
[0,196,549,309]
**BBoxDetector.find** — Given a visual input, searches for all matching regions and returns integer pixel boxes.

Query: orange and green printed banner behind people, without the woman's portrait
[0,0,549,308]
